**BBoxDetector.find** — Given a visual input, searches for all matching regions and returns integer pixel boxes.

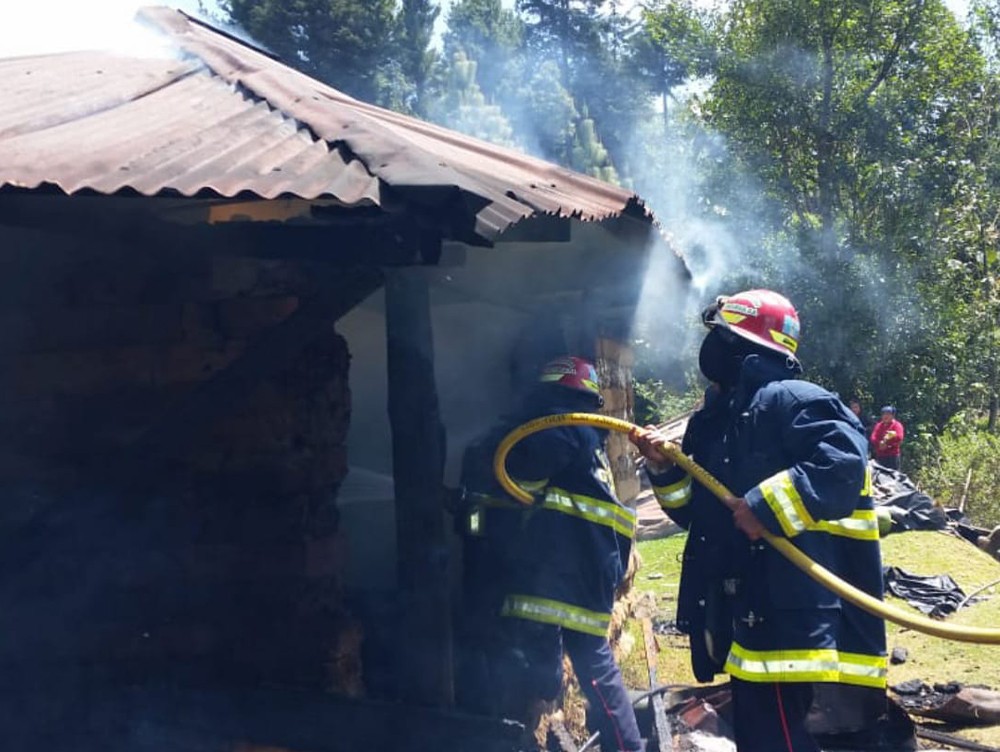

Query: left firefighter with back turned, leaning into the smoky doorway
[460,357,642,752]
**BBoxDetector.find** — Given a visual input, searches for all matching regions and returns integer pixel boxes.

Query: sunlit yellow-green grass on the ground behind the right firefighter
[622,532,1000,747]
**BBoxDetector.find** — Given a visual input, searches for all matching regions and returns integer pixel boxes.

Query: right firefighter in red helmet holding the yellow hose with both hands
[632,290,886,752]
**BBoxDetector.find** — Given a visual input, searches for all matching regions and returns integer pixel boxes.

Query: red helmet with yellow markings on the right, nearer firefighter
[702,290,799,360]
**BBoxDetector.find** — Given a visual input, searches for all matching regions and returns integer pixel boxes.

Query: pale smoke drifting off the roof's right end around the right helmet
[626,78,921,388]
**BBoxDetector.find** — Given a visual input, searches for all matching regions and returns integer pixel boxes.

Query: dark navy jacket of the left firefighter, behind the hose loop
[464,406,635,636]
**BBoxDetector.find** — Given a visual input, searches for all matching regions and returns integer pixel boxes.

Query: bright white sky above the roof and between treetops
[0,0,968,57]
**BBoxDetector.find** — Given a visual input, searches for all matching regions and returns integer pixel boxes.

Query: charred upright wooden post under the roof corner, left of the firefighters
[385,268,454,705]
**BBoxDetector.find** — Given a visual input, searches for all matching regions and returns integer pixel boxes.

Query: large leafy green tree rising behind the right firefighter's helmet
[703,0,982,434]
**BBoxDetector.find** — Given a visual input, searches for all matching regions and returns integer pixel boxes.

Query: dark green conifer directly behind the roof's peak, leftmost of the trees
[220,0,396,102]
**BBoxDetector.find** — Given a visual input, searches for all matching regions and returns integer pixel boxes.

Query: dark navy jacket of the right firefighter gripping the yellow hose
[652,355,885,687]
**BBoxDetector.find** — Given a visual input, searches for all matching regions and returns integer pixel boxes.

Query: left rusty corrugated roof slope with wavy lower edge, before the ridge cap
[0,53,380,205]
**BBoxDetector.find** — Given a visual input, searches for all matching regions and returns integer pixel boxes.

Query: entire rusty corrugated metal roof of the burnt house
[0,8,647,239]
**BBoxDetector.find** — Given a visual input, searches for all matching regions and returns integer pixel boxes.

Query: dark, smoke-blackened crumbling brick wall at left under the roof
[0,227,361,732]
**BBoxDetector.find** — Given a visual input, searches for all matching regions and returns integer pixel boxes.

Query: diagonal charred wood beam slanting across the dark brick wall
[126,267,383,472]
